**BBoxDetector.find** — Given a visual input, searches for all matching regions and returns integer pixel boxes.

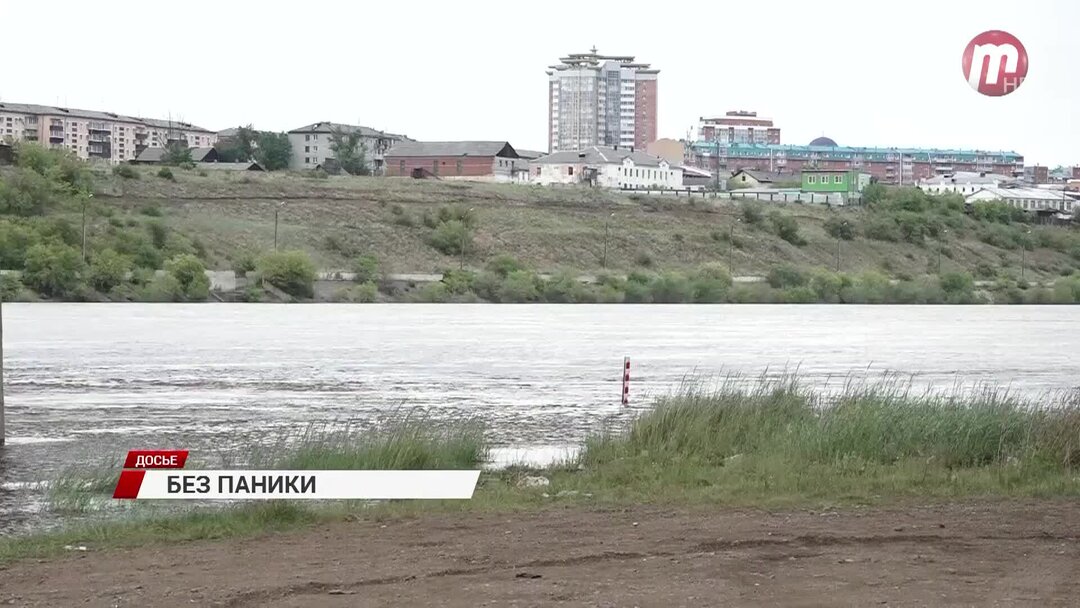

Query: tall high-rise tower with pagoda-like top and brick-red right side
[548,48,660,152]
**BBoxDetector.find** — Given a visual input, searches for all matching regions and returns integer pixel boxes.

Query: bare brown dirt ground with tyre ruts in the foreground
[0,501,1080,608]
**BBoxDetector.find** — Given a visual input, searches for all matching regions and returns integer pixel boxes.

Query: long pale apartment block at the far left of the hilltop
[0,102,217,163]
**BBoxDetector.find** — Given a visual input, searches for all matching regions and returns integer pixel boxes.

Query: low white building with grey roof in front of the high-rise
[530,146,684,190]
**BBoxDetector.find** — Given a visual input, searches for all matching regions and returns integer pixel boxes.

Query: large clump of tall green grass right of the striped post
[579,377,1080,470]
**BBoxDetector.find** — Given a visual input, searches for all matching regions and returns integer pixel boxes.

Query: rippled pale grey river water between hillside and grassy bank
[0,303,1080,531]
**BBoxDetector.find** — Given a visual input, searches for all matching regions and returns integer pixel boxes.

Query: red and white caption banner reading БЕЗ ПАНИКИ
[112,449,480,500]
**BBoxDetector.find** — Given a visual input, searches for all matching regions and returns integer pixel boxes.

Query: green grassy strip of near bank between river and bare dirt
[0,378,1080,559]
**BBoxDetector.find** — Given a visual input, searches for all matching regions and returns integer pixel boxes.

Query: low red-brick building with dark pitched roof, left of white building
[386,141,529,181]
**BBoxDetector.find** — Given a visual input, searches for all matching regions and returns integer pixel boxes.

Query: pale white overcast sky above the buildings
[0,0,1080,165]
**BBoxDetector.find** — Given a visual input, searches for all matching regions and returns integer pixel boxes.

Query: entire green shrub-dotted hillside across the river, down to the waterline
[0,145,1080,303]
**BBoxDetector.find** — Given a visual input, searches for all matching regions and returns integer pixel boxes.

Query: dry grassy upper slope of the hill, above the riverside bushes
[8,156,1080,300]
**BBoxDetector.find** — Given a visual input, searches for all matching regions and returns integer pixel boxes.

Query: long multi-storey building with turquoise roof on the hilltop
[688,137,1024,186]
